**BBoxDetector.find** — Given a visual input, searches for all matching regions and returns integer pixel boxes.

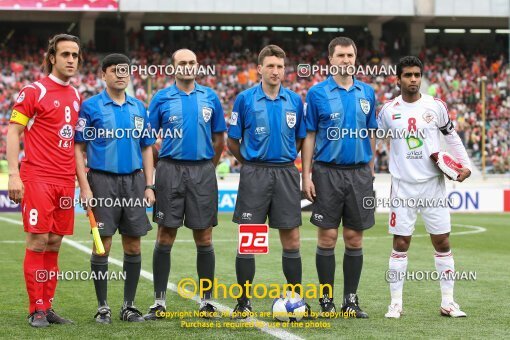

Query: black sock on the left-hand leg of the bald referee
[152,242,172,307]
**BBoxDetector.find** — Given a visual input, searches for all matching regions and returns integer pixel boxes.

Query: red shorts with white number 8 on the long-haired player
[21,182,74,235]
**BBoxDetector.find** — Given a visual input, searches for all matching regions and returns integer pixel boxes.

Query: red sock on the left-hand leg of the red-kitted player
[23,249,48,314]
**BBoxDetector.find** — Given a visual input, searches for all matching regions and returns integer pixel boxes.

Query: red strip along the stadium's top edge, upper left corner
[0,0,119,11]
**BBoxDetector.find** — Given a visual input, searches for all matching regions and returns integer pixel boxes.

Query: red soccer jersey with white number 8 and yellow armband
[10,75,81,187]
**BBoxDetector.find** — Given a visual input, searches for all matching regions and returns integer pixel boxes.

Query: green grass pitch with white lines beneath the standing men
[0,213,510,339]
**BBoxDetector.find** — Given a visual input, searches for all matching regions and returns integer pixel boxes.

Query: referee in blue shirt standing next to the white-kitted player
[302,37,377,318]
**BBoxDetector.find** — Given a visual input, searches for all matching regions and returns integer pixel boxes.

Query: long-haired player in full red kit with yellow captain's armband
[7,34,82,327]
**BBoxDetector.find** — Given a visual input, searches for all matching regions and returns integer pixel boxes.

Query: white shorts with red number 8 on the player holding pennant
[388,176,452,236]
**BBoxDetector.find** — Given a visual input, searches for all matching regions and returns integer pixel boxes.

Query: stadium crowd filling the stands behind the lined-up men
[0,31,510,173]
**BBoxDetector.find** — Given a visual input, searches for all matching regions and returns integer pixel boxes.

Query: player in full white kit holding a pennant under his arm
[377,56,471,318]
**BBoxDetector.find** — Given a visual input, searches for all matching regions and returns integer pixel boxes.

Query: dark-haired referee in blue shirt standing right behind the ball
[228,45,309,318]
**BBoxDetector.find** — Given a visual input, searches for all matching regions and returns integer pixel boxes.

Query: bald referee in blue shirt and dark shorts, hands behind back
[145,49,227,320]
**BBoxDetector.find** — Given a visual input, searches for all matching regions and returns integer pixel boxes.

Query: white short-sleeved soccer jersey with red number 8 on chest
[377,94,455,183]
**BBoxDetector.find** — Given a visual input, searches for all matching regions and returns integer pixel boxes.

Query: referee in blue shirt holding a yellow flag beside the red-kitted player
[75,54,155,323]
